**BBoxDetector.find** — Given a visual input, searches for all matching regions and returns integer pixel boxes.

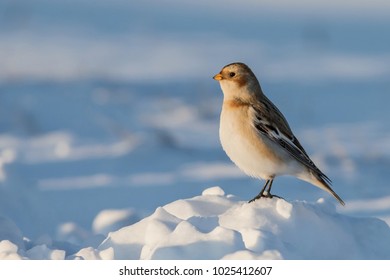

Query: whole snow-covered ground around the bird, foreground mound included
[0,0,390,259]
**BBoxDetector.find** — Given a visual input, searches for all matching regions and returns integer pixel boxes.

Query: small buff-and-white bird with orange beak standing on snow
[213,62,345,206]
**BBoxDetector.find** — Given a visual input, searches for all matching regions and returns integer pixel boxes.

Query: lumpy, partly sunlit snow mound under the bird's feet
[74,187,390,259]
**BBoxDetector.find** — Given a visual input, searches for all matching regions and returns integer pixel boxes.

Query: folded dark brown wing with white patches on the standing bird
[251,99,331,184]
